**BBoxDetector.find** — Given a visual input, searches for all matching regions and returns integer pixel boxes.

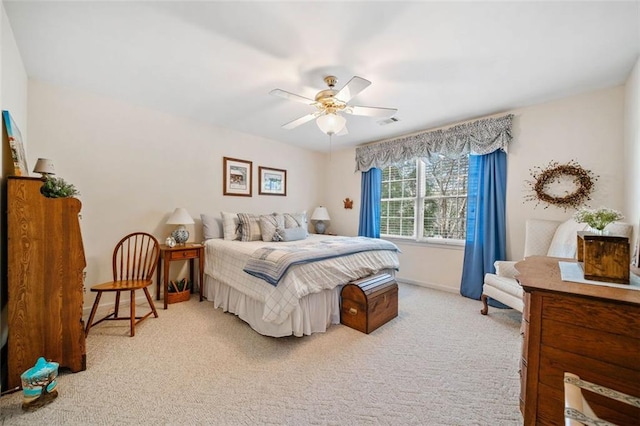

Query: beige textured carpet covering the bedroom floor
[0,285,522,425]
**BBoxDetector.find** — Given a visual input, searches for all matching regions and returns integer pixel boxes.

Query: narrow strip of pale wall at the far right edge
[623,58,640,266]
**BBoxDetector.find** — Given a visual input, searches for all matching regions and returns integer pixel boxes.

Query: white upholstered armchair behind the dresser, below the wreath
[480,219,633,315]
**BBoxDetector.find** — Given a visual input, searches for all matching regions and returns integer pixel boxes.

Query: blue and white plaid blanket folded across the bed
[243,237,399,286]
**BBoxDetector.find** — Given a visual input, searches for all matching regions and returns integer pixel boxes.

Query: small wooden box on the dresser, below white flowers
[578,231,631,284]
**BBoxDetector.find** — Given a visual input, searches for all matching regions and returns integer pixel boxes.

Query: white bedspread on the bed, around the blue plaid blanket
[204,235,399,324]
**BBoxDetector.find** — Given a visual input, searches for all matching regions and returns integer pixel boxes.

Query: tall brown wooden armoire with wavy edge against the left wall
[7,176,86,389]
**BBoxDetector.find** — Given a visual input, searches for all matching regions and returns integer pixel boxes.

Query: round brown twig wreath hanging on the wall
[525,160,598,210]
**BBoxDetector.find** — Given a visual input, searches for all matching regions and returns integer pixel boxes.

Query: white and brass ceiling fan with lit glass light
[269,75,398,135]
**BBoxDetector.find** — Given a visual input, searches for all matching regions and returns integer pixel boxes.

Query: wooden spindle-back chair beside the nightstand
[84,232,160,337]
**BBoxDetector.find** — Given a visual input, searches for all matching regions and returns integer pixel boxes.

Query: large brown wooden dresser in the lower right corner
[516,256,640,425]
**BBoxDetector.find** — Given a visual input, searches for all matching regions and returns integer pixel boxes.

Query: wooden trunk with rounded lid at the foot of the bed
[340,274,398,334]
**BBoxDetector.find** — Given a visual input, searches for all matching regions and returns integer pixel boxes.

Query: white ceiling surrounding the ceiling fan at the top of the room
[4,0,640,151]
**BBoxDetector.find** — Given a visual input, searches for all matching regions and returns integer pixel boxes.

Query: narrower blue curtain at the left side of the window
[358,167,382,238]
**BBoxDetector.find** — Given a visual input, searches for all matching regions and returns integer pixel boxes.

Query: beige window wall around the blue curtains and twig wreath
[328,87,630,292]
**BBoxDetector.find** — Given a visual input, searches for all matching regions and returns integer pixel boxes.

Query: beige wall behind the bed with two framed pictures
[28,81,326,307]
